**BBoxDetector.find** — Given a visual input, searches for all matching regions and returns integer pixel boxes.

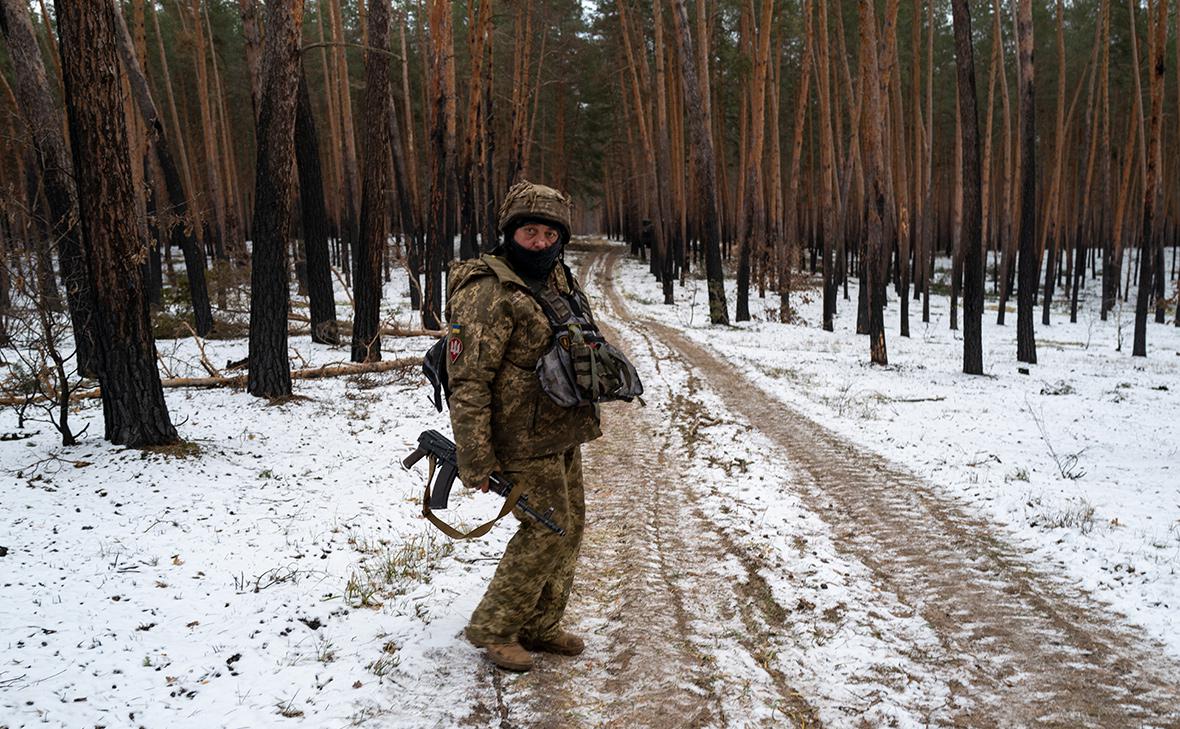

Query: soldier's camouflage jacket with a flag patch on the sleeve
[447,255,602,486]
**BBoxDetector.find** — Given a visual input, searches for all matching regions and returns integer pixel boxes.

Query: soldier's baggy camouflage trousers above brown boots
[466,446,585,643]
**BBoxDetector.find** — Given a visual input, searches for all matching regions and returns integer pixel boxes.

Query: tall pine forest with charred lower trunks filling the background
[0,0,1180,441]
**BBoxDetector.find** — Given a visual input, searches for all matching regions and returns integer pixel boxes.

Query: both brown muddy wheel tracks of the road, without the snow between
[460,247,1180,728]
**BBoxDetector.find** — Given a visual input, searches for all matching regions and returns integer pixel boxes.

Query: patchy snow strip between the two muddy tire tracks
[589,273,961,727]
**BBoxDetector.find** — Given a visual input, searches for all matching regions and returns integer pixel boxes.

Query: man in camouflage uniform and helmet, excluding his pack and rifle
[447,182,602,671]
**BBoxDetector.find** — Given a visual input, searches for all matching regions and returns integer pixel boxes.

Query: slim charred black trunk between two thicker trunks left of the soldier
[295,68,340,344]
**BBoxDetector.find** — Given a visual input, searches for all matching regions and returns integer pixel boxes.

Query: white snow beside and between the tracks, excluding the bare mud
[0,237,1180,729]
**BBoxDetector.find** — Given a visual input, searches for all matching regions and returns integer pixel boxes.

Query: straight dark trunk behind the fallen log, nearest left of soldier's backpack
[353,0,389,362]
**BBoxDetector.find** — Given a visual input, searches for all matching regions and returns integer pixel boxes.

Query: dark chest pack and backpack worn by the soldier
[422,263,643,413]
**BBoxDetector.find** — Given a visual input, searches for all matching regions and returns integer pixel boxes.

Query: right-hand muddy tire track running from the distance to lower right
[595,249,1180,728]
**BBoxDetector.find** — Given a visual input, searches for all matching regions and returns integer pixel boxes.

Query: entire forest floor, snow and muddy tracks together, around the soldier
[0,235,1180,729]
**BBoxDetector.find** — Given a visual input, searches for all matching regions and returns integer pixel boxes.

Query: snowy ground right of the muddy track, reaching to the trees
[617,245,1180,657]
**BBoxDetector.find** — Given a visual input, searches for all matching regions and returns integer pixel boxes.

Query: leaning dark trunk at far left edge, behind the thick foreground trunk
[0,0,98,376]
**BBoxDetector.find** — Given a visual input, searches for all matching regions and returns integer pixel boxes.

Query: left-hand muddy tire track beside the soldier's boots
[466,245,819,729]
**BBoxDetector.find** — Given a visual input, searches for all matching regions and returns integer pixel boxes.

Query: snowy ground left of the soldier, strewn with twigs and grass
[0,271,523,729]
